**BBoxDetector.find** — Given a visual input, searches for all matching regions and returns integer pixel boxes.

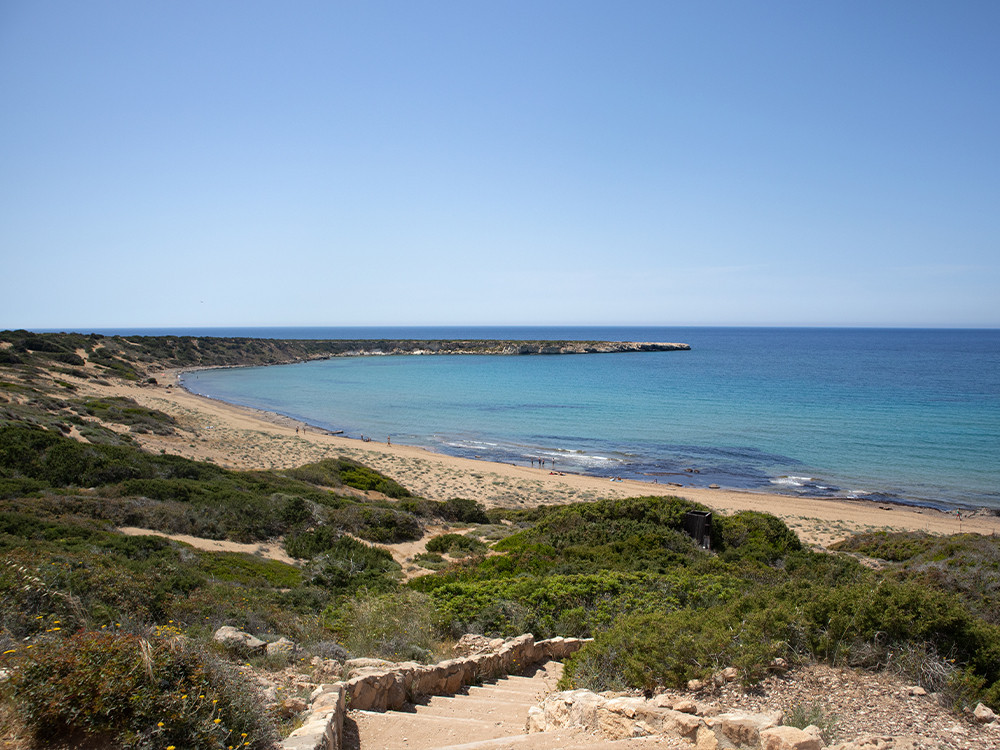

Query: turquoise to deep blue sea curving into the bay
[76,327,1000,509]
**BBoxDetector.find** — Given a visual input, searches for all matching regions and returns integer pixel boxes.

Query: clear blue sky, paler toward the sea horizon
[0,0,1000,328]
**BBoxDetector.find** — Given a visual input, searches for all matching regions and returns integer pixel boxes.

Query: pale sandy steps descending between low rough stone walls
[343,661,670,750]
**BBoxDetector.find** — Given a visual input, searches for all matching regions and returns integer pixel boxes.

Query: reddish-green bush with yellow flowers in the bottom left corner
[5,632,277,750]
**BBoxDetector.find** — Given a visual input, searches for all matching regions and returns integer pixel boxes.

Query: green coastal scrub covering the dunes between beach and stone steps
[0,332,1000,748]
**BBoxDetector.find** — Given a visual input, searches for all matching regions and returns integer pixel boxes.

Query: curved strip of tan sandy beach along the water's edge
[81,371,1000,547]
